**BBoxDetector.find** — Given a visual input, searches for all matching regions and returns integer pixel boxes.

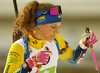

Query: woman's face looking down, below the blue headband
[37,22,61,41]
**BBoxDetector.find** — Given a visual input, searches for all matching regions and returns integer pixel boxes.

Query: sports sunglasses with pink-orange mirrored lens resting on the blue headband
[36,5,62,20]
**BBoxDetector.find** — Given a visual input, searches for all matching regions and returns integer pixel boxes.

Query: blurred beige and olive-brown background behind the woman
[0,0,100,73]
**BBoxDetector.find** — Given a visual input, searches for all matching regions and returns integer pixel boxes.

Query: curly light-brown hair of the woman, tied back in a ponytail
[15,1,54,35]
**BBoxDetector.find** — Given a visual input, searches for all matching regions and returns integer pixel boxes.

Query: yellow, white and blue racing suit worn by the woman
[3,34,87,73]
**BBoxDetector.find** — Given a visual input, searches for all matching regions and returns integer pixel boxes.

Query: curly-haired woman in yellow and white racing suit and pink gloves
[3,1,97,73]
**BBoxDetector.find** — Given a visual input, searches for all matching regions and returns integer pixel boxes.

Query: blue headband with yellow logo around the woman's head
[35,10,61,25]
